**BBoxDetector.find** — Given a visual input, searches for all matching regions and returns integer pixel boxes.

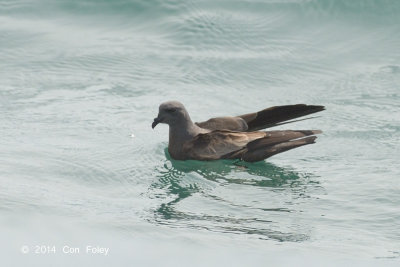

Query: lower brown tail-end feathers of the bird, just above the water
[242,136,317,162]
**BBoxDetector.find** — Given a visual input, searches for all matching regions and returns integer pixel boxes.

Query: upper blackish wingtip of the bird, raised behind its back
[239,104,325,131]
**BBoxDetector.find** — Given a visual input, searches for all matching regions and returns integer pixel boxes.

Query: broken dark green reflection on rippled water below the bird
[151,149,319,241]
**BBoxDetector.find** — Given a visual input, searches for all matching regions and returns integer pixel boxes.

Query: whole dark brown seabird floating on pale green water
[152,101,325,162]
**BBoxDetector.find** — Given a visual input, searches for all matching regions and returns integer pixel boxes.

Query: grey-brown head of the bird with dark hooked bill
[151,101,190,129]
